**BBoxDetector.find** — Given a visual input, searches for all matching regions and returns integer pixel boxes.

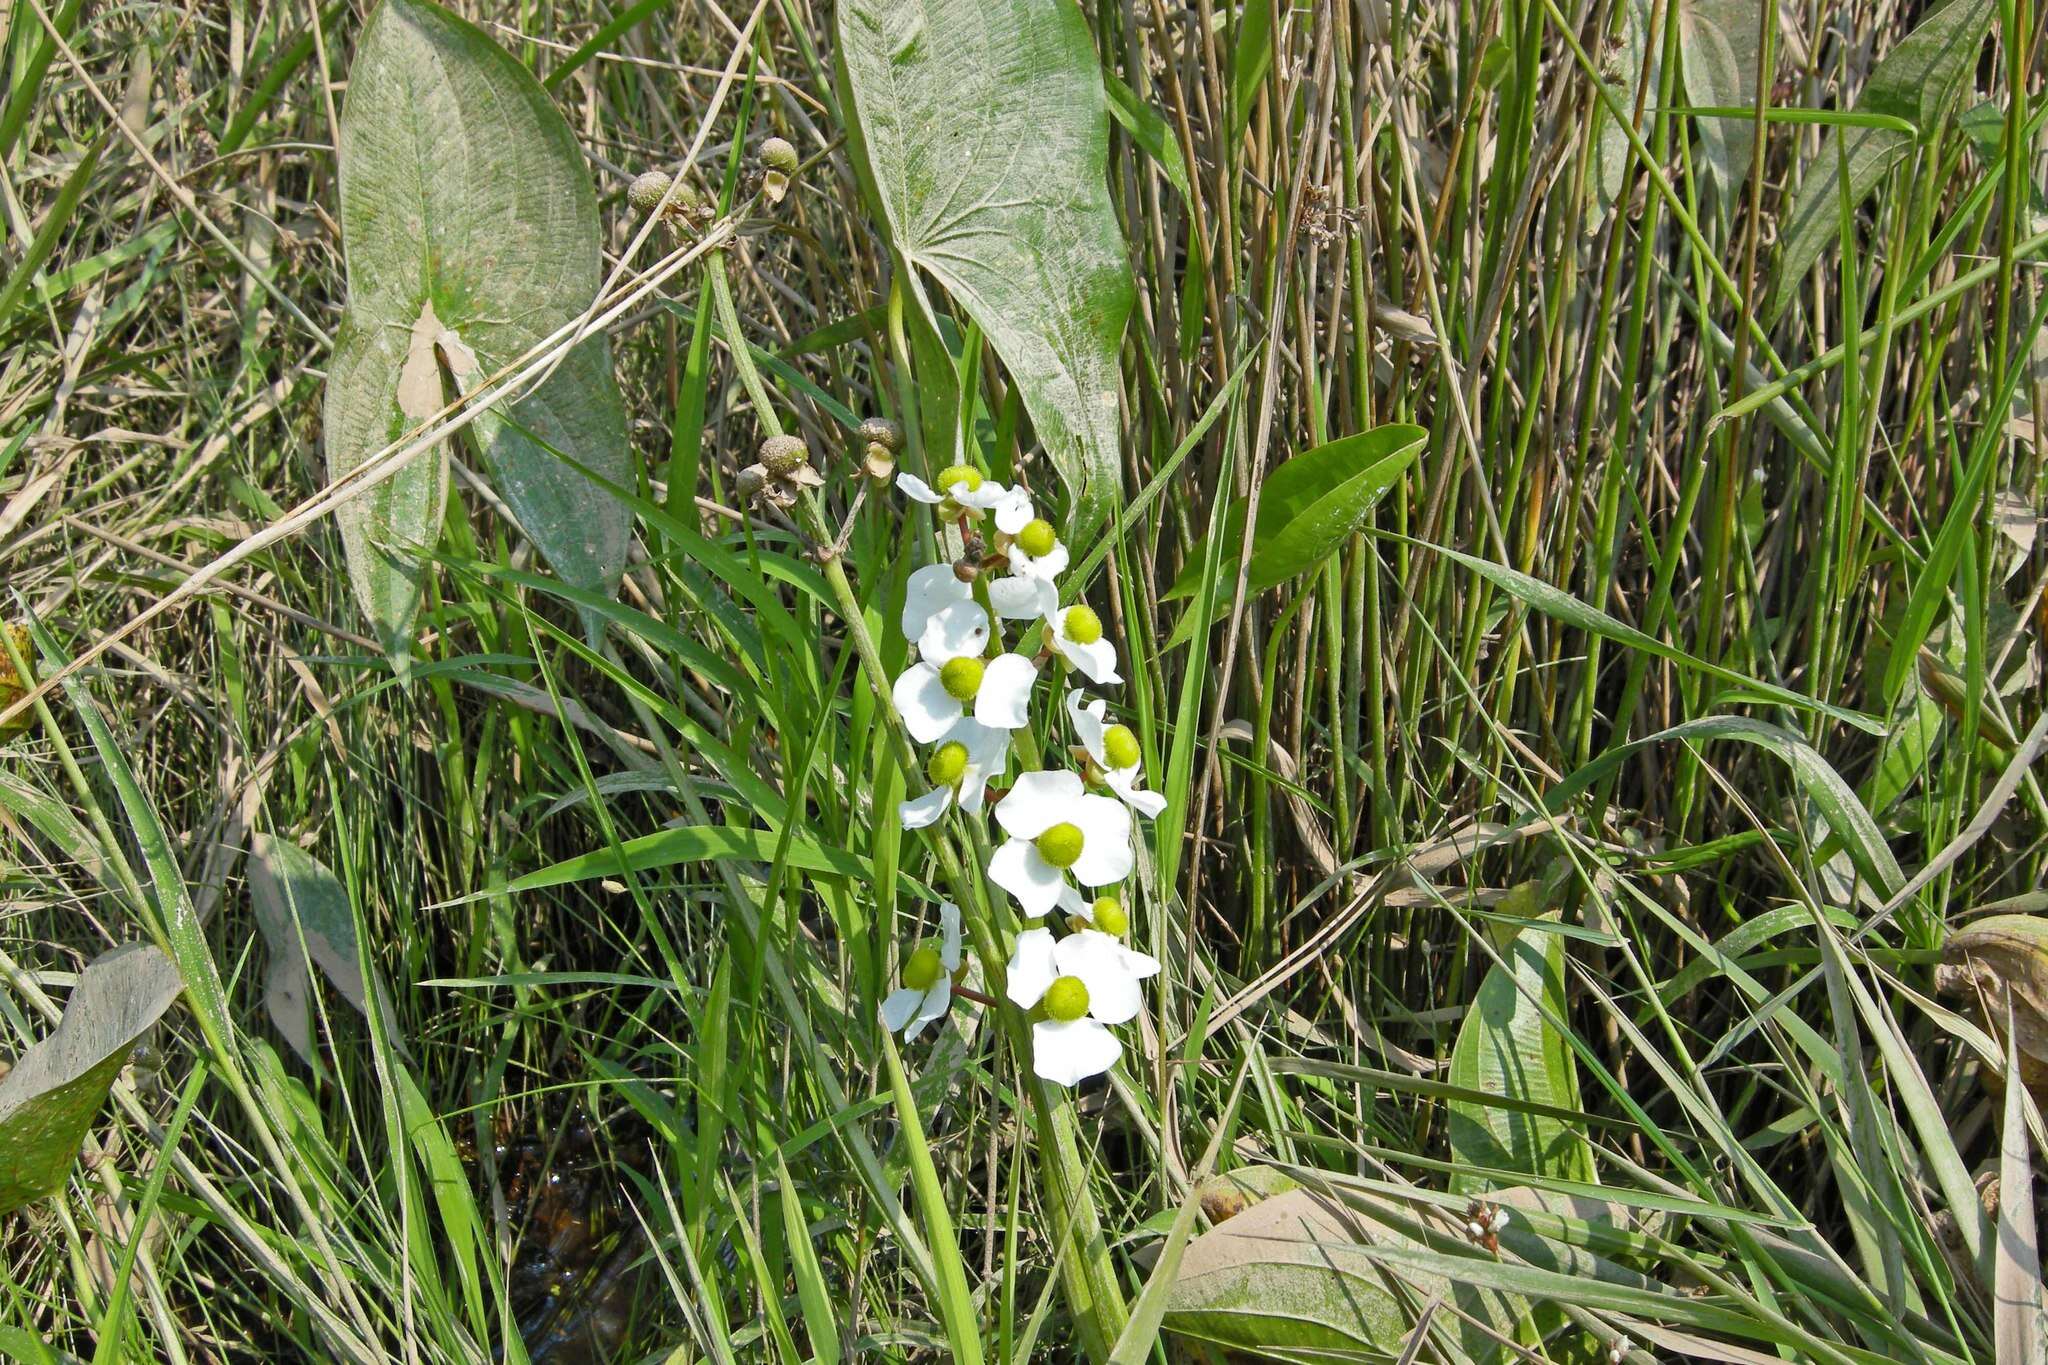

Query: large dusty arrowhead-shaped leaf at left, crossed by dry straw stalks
[326,0,631,655]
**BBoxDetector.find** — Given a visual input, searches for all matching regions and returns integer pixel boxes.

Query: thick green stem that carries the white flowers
[797,489,1126,1361]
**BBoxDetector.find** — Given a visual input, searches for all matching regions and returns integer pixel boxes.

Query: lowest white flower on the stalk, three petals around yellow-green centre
[1008,929,1159,1085]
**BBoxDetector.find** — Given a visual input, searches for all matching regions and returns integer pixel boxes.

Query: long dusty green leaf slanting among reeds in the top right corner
[1767,0,1997,319]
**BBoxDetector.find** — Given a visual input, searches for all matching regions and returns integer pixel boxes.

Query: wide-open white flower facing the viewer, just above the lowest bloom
[989,772,1135,919]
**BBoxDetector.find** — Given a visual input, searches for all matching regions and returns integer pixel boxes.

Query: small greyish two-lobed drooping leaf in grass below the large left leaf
[250,835,367,1062]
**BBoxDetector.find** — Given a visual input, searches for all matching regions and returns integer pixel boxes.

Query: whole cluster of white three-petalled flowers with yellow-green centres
[881,465,1165,1085]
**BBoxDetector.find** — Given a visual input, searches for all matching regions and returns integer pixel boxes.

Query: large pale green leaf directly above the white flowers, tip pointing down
[838,0,1133,540]
